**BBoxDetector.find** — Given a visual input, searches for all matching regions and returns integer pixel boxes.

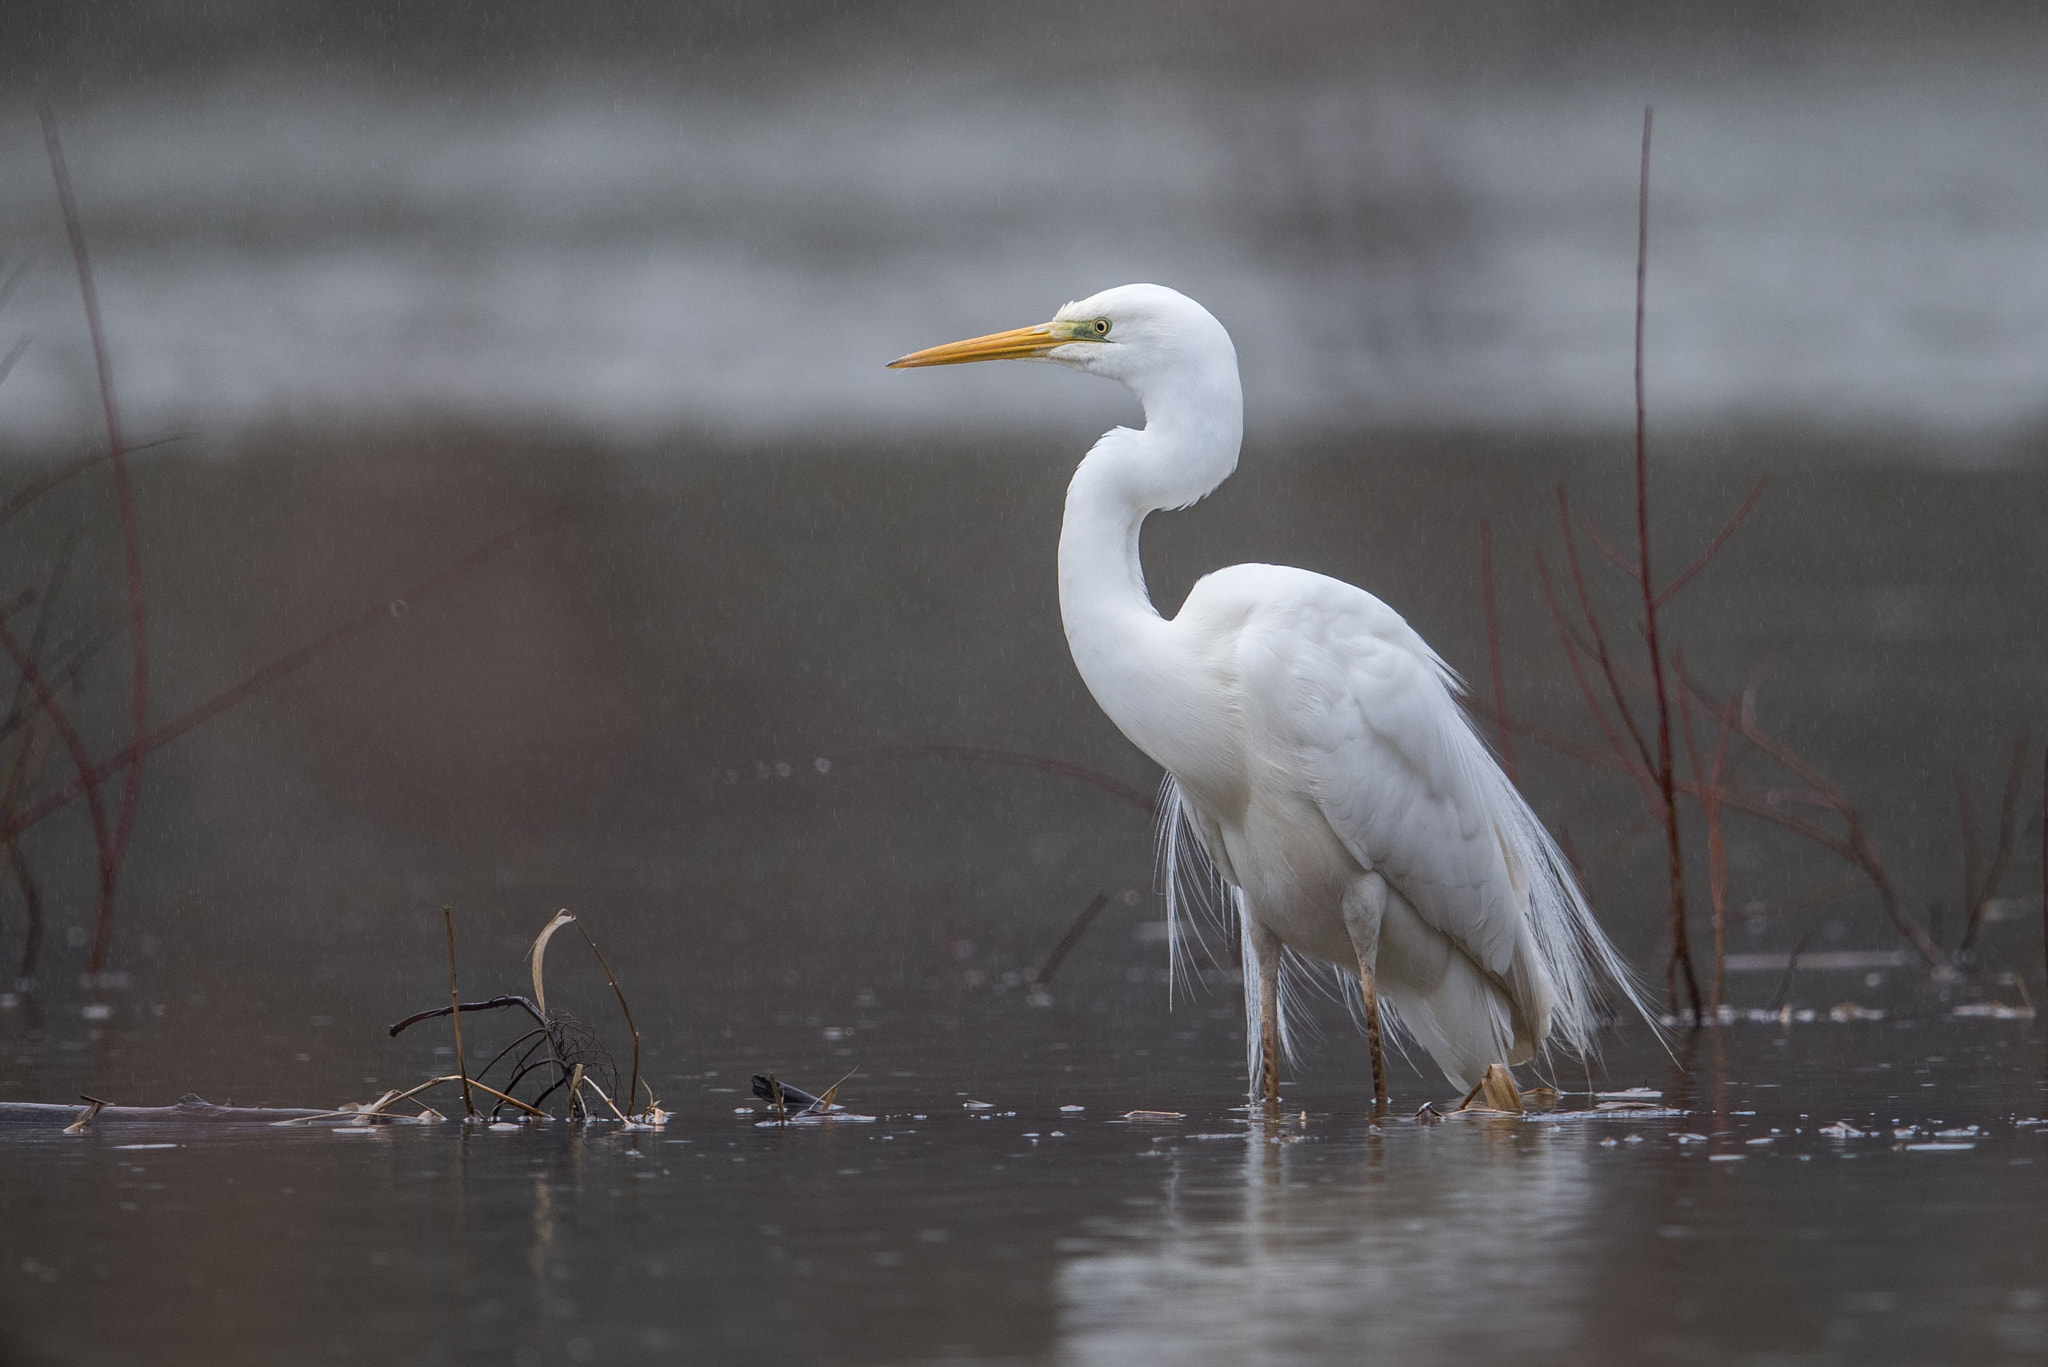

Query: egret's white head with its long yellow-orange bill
[889,285,1237,393]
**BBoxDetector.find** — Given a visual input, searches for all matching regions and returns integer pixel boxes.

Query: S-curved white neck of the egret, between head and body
[1059,357,1243,779]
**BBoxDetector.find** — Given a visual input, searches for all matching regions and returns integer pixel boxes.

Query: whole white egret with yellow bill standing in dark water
[889,285,1642,1107]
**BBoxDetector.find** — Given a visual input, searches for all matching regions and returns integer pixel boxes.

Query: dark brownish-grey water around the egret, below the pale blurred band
[0,432,2048,1363]
